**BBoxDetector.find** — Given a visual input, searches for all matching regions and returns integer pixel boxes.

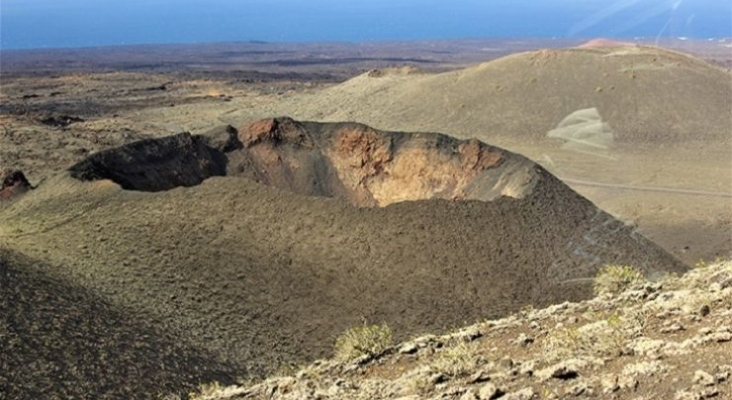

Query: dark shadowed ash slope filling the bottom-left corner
[0,250,238,400]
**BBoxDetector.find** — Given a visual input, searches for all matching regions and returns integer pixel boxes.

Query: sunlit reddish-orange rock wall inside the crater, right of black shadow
[239,118,534,207]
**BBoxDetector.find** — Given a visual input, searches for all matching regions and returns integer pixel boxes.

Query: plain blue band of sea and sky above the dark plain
[0,0,732,50]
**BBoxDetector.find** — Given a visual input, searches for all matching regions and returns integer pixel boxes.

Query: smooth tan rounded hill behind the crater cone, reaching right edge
[230,41,732,265]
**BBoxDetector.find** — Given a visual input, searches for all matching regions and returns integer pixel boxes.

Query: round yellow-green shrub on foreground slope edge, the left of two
[335,324,392,361]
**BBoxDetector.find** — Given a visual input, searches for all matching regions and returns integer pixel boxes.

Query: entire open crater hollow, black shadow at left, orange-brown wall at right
[70,117,548,207]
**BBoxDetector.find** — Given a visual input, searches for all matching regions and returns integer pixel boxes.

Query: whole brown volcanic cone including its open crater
[0,118,684,394]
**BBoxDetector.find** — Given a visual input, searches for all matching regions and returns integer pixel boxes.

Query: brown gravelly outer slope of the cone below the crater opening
[0,124,685,393]
